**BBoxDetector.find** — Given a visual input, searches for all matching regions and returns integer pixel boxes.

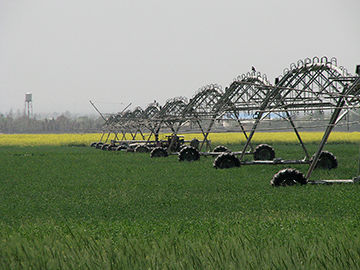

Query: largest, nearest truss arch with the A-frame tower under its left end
[211,57,360,169]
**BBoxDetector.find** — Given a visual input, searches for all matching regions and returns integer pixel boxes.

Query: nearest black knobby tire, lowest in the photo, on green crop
[270,168,307,187]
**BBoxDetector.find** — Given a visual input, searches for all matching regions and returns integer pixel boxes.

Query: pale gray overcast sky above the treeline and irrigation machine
[0,0,360,114]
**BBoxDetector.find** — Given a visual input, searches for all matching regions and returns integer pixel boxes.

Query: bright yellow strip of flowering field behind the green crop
[0,132,360,146]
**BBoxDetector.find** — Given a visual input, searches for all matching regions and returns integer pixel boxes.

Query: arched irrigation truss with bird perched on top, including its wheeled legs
[183,71,275,165]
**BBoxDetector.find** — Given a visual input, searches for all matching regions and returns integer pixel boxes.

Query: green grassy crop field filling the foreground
[0,144,360,269]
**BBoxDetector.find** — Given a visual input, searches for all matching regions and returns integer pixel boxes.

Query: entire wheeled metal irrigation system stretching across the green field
[91,57,360,186]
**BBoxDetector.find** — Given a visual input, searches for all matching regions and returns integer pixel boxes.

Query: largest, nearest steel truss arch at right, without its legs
[264,57,351,113]
